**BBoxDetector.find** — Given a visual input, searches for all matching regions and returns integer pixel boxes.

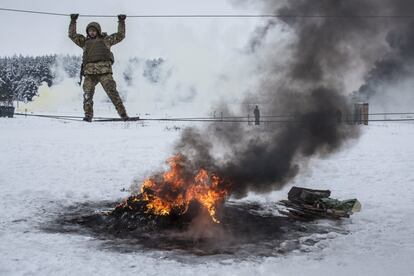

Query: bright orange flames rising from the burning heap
[122,155,228,223]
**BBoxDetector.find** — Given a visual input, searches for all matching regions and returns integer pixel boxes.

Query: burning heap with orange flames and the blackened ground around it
[46,155,358,258]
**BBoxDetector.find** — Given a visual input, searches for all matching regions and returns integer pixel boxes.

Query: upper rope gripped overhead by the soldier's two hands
[0,8,414,19]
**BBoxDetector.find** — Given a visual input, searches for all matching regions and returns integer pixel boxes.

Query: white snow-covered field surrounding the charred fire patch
[0,118,414,275]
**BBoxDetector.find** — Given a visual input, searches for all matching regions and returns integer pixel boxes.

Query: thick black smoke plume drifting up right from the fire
[169,0,414,197]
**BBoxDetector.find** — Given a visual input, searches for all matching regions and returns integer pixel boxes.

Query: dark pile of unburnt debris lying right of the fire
[279,187,361,220]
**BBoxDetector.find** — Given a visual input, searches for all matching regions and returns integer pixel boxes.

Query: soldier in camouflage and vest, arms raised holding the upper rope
[69,14,129,122]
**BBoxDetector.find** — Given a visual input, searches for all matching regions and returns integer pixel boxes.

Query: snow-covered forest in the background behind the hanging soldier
[0,55,164,104]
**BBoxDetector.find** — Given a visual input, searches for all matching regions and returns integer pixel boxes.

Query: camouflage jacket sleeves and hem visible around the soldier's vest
[69,20,125,75]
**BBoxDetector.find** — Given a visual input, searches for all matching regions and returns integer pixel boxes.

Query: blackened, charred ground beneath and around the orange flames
[41,201,347,259]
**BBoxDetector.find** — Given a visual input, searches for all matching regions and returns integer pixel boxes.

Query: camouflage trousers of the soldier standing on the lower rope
[83,73,127,118]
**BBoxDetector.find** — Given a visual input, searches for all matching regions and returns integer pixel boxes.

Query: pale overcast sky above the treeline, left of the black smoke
[0,0,258,56]
